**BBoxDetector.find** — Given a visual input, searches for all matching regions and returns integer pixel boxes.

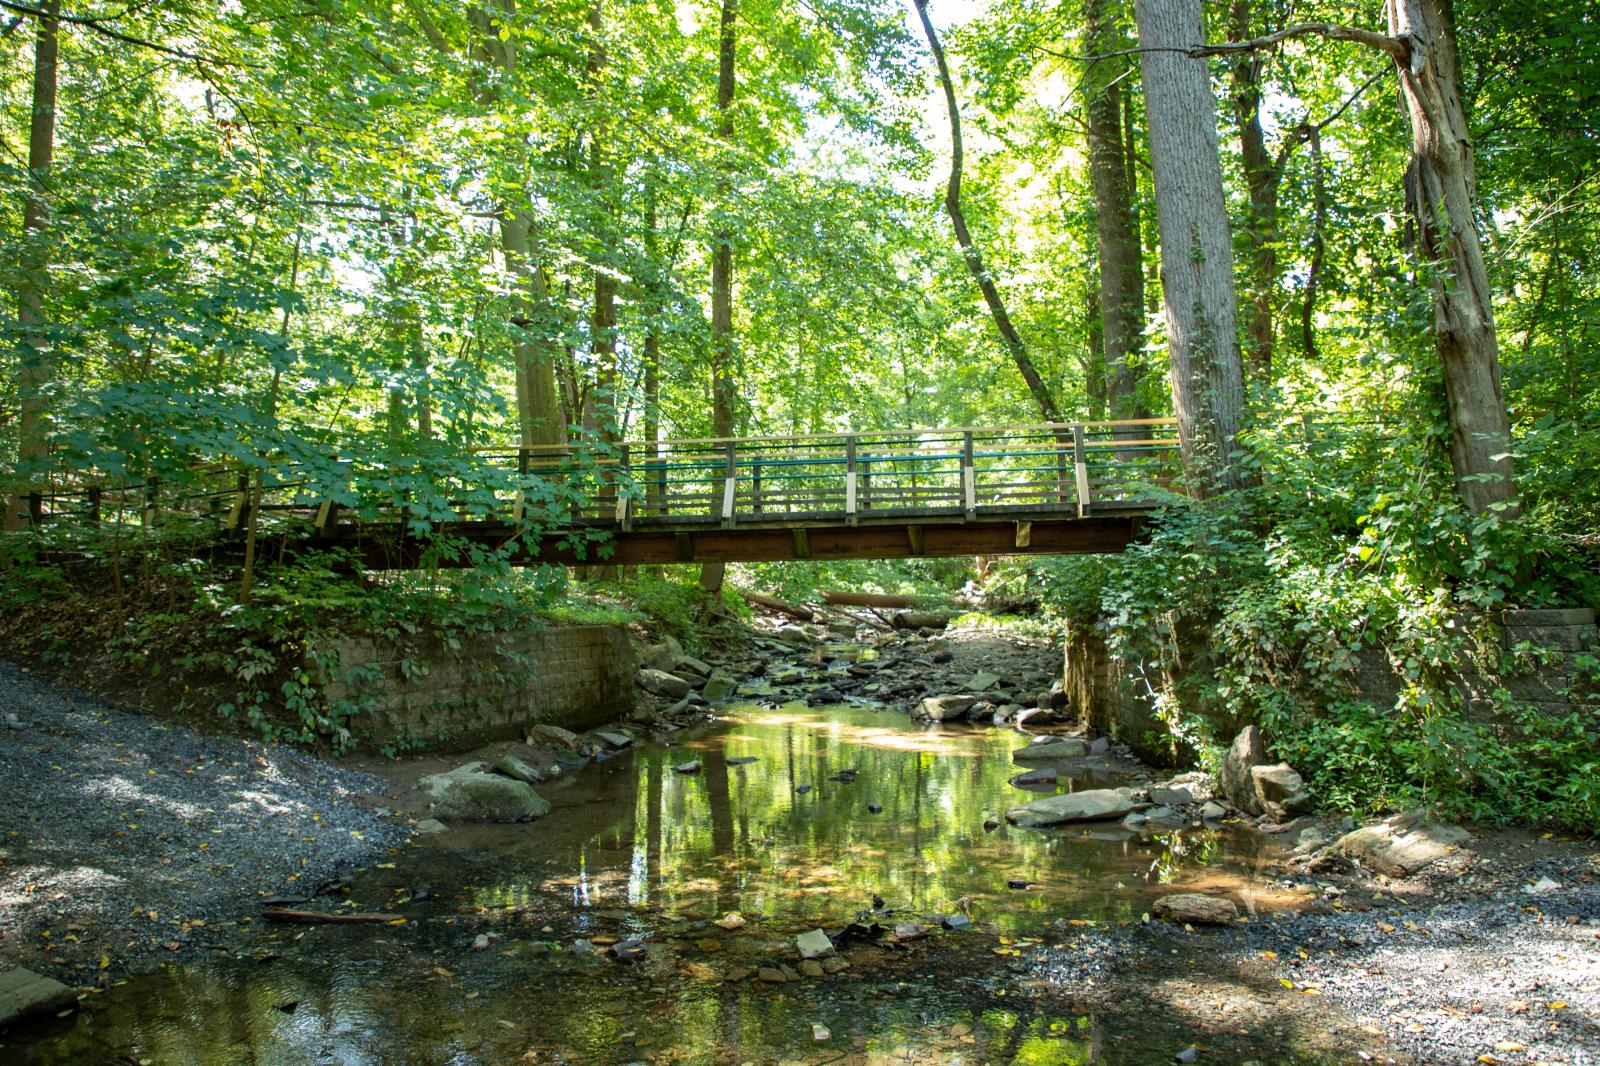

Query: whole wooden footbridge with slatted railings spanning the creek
[6,418,1179,568]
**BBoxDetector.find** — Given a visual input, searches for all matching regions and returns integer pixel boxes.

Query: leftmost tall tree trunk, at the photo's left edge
[3,0,61,530]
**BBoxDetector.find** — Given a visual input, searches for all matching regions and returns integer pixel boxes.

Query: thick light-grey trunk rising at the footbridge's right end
[1134,0,1246,498]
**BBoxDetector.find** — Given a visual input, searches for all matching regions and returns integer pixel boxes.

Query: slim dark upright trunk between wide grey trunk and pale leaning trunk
[1229,0,1283,386]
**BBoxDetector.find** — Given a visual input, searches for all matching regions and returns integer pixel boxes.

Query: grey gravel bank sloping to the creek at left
[0,663,400,984]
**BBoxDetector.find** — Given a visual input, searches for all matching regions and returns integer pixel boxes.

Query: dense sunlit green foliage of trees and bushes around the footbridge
[0,0,1600,826]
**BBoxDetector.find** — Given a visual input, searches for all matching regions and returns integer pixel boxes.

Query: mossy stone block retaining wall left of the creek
[322,626,635,751]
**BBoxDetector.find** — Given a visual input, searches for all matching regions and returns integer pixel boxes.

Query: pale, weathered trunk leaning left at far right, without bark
[1389,0,1517,517]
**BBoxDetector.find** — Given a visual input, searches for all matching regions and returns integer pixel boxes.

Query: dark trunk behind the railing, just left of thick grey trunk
[1083,0,1149,435]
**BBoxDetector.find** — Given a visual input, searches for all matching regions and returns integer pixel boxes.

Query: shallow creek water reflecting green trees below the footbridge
[9,704,1299,1066]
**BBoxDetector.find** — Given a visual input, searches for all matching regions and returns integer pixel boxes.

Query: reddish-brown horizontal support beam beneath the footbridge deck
[331,514,1146,570]
